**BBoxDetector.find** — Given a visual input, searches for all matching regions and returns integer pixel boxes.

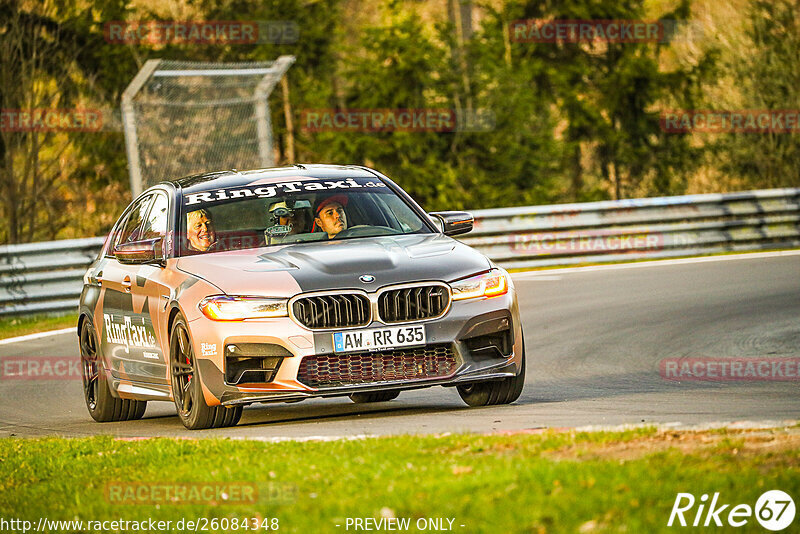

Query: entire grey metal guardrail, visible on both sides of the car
[0,188,800,316]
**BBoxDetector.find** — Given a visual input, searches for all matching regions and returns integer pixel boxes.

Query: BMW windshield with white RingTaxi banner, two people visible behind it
[179,178,432,256]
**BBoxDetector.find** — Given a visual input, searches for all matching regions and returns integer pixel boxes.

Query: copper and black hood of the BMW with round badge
[177,234,491,296]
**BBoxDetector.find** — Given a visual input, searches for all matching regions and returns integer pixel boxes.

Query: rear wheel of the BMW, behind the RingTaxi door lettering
[79,318,147,423]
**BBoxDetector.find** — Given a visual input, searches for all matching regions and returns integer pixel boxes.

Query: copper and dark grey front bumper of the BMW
[190,287,523,406]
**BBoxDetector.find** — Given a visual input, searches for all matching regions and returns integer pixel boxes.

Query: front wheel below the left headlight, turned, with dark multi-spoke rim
[169,314,242,430]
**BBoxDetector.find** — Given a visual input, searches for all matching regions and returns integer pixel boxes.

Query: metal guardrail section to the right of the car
[462,188,800,268]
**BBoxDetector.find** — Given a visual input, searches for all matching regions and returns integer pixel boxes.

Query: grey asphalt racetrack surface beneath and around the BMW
[0,255,800,438]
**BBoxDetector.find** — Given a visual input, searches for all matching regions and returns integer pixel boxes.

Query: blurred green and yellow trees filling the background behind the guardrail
[0,0,800,242]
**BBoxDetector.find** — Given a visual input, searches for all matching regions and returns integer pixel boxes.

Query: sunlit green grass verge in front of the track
[0,427,800,533]
